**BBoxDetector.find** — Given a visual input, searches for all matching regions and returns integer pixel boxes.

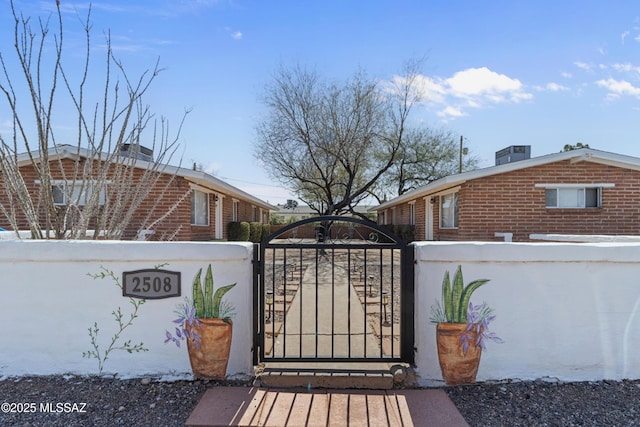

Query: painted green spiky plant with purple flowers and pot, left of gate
[165,264,236,379]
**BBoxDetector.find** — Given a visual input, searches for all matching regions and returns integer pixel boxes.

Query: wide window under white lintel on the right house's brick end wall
[536,184,614,209]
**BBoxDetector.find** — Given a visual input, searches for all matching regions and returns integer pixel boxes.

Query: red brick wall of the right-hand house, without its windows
[382,160,640,241]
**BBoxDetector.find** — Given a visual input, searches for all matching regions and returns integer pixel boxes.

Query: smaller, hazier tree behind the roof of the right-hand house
[371,128,479,202]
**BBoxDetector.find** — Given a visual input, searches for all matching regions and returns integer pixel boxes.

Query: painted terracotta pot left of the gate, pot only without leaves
[187,319,233,380]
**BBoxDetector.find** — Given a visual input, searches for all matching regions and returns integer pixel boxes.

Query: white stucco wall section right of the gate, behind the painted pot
[415,242,640,385]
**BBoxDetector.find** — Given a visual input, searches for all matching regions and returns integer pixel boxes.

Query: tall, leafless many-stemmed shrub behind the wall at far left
[0,1,187,239]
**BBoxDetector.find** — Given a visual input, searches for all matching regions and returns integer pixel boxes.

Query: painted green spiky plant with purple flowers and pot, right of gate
[431,266,502,385]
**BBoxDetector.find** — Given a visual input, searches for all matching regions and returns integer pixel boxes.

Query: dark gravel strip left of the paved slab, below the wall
[0,376,240,427]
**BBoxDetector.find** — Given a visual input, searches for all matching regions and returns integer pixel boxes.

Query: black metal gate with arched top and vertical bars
[254,216,414,364]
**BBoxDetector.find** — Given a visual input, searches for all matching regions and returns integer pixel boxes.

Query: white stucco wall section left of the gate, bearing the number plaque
[0,240,253,378]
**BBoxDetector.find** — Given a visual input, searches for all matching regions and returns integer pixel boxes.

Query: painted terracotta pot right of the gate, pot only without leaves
[436,323,482,385]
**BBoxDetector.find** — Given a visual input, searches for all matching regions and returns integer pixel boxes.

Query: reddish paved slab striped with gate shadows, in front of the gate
[186,387,468,427]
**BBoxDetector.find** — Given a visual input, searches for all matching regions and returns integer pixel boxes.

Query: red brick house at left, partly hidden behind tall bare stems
[0,146,277,241]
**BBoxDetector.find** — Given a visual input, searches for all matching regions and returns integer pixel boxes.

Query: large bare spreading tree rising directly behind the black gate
[256,61,419,215]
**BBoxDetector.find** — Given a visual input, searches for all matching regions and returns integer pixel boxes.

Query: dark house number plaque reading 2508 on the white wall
[122,269,180,299]
